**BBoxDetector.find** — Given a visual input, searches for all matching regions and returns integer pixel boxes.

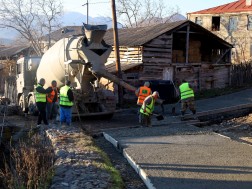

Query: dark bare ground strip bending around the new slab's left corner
[81,109,147,189]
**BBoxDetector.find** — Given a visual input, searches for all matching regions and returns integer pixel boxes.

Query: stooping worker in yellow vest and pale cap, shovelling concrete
[140,91,159,127]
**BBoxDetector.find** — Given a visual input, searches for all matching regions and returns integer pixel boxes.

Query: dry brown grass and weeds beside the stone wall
[0,134,54,189]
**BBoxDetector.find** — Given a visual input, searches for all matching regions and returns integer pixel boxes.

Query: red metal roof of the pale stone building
[188,0,252,14]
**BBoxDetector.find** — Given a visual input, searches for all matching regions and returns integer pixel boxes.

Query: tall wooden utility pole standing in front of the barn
[111,0,123,107]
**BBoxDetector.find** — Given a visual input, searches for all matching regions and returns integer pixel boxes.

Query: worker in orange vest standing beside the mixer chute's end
[135,81,152,123]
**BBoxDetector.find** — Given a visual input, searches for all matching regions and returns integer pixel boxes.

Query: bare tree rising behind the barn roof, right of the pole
[117,0,179,27]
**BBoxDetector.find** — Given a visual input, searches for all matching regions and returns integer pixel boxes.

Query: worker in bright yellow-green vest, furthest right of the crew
[179,79,196,120]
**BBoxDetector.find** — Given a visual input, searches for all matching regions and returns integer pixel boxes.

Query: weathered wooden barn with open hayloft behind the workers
[104,20,232,94]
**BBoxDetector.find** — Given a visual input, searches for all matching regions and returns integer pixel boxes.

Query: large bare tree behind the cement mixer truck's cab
[0,0,62,55]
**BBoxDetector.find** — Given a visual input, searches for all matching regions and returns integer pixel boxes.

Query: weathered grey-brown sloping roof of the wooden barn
[104,20,188,46]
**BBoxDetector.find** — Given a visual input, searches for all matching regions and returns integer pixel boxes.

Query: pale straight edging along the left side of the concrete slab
[103,132,156,189]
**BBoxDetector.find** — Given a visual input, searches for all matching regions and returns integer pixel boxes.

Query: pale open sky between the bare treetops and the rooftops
[62,0,235,17]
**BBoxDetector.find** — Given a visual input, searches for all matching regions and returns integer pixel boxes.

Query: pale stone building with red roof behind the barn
[187,0,252,63]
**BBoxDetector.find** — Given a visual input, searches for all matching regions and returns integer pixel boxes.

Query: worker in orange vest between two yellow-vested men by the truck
[46,80,58,123]
